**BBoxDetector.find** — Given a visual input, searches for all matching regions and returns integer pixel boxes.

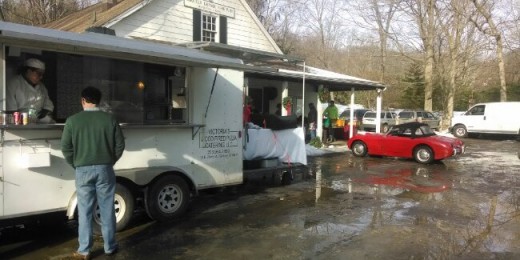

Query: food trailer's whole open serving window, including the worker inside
[4,46,189,125]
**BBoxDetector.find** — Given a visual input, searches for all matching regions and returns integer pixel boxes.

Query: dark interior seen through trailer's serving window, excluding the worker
[6,46,188,124]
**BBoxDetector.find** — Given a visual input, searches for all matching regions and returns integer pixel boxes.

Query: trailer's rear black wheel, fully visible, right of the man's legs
[146,175,190,221]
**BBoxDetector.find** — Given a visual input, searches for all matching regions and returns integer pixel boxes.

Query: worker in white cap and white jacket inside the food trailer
[6,58,54,123]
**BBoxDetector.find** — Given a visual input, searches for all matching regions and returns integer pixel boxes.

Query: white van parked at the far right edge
[450,102,520,137]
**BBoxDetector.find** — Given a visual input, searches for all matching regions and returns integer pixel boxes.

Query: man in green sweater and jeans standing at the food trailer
[61,87,125,259]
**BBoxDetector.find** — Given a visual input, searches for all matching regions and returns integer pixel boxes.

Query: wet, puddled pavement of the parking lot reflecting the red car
[0,138,520,259]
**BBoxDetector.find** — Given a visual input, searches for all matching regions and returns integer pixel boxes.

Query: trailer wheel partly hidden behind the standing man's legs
[93,183,135,234]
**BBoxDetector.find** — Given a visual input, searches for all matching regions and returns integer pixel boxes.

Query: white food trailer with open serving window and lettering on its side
[0,22,306,230]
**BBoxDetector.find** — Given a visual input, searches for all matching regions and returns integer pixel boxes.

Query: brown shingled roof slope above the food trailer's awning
[41,0,143,33]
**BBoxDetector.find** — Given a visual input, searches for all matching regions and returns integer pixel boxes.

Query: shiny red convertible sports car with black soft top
[347,122,464,164]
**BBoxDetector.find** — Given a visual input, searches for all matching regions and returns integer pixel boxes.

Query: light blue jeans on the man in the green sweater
[76,165,117,255]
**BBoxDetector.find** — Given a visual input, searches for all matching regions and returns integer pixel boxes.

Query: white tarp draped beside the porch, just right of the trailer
[244,127,307,165]
